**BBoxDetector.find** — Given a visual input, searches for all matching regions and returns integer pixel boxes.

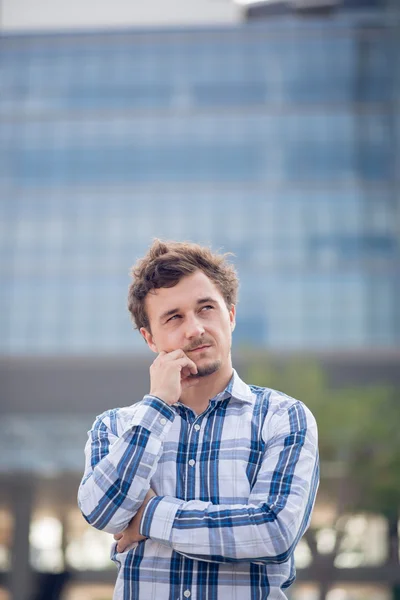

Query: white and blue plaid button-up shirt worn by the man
[78,371,319,600]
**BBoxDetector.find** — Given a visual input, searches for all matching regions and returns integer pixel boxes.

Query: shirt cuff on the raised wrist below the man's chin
[130,395,176,437]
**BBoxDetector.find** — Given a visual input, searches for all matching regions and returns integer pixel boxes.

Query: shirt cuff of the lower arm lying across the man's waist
[139,496,185,546]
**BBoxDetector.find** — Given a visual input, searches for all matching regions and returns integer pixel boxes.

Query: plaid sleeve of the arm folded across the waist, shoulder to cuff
[140,401,319,564]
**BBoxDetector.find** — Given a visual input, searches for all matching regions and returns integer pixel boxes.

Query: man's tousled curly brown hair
[128,239,239,331]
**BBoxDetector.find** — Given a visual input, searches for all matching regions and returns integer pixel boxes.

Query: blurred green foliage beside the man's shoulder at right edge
[246,356,400,518]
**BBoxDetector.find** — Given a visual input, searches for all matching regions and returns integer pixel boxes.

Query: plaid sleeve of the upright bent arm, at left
[78,396,175,533]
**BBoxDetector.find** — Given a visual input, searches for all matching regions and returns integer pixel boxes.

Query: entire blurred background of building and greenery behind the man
[0,0,400,600]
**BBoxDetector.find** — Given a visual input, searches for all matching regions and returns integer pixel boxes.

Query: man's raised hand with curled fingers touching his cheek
[150,350,199,406]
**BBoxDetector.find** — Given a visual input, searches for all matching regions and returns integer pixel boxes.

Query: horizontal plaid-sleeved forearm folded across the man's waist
[140,462,319,563]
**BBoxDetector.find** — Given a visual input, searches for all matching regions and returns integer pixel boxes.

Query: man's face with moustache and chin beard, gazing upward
[140,271,235,376]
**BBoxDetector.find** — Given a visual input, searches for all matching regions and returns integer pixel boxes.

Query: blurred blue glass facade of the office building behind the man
[0,12,400,354]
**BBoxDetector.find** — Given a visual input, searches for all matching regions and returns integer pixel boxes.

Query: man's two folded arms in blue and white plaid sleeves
[78,396,319,563]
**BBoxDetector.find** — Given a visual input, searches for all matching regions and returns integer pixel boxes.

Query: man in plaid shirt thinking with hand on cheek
[79,240,319,600]
